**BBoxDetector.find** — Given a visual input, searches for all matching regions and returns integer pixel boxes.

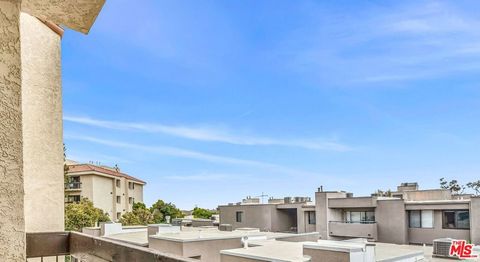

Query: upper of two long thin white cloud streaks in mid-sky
[64,115,352,152]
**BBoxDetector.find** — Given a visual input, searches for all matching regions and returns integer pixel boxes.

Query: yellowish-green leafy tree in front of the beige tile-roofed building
[65,198,110,231]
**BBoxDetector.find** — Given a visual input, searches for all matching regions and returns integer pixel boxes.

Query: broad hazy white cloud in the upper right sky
[272,1,480,86]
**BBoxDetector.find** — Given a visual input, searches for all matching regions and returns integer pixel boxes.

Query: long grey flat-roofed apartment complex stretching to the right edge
[219,183,480,244]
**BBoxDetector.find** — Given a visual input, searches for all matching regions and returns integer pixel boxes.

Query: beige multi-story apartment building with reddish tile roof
[65,164,146,221]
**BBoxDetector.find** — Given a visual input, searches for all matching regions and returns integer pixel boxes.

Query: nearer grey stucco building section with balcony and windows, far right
[316,183,480,245]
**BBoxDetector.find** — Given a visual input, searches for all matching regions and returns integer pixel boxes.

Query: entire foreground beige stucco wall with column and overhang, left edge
[0,0,104,261]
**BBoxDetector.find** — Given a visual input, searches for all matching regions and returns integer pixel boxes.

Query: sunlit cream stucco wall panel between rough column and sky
[20,13,64,232]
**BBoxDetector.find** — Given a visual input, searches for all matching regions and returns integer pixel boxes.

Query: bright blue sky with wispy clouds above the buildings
[62,0,480,209]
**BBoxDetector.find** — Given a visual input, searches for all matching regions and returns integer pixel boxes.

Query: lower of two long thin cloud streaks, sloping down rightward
[64,134,322,177]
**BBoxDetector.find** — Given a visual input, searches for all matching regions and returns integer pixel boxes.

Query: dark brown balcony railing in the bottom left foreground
[27,232,198,262]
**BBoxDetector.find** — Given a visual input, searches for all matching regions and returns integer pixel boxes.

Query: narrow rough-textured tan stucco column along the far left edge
[0,0,26,261]
